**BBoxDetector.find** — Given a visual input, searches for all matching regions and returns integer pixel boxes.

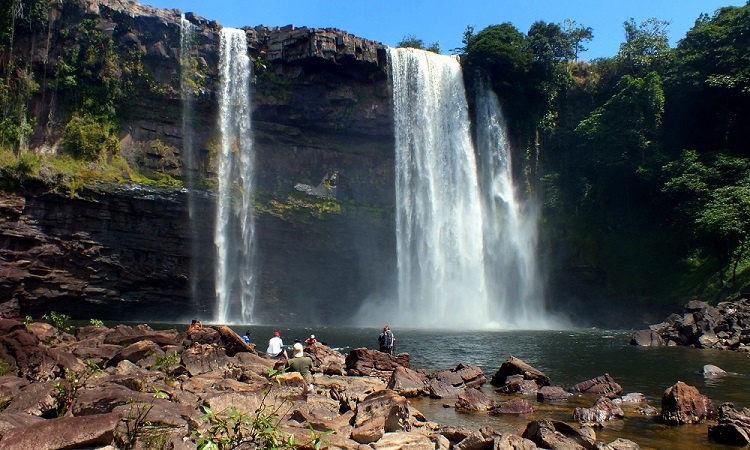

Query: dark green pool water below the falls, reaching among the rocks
[145,324,750,450]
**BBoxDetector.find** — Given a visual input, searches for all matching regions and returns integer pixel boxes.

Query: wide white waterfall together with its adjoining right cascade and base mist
[358,48,568,329]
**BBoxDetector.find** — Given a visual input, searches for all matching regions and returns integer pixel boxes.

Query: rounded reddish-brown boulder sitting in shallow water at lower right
[661,381,718,425]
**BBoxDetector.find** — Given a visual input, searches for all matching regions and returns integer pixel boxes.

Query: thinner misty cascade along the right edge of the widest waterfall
[475,74,555,329]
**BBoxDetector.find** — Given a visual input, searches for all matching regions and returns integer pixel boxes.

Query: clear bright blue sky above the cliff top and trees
[141,0,746,59]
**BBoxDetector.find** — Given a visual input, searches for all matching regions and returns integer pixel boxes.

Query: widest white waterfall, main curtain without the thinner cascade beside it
[388,48,490,329]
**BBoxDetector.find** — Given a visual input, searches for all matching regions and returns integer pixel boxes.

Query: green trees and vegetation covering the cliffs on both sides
[0,0,750,316]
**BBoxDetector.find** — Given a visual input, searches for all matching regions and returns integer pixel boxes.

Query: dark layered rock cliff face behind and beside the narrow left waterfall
[0,0,395,324]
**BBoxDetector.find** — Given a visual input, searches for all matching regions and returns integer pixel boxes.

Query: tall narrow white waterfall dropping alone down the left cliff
[214,28,256,323]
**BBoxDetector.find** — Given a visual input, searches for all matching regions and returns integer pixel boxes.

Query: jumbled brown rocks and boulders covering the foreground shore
[0,319,750,450]
